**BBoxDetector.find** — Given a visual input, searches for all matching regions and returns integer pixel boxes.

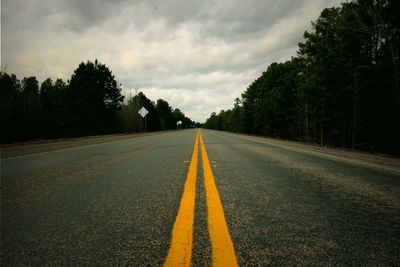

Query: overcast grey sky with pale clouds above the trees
[1,0,343,122]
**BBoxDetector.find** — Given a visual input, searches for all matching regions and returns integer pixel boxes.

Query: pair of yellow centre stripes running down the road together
[164,130,238,266]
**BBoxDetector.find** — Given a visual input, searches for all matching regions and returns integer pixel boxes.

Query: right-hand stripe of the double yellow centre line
[199,132,239,266]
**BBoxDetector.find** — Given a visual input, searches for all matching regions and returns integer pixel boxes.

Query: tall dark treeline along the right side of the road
[205,0,400,155]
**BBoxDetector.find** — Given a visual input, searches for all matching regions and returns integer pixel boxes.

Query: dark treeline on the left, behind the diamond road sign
[0,60,194,143]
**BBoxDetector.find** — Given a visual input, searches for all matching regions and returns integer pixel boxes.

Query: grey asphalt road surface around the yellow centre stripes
[1,130,400,266]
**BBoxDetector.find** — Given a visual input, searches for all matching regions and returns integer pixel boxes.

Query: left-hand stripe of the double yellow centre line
[164,131,200,266]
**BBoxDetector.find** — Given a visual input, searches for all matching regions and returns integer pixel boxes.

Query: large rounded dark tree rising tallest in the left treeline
[66,60,124,136]
